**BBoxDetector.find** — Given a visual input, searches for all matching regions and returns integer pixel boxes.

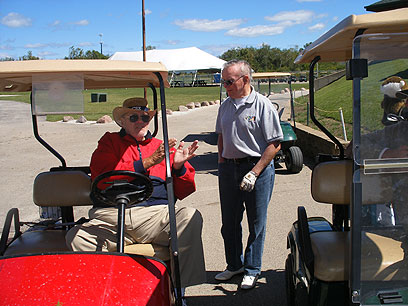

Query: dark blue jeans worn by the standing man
[218,161,275,275]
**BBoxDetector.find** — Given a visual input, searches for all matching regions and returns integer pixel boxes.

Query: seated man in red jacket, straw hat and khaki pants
[66,98,209,287]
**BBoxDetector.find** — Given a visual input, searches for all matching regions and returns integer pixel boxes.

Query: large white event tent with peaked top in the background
[109,47,225,83]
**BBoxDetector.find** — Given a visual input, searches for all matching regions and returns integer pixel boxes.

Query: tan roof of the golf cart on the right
[295,8,408,64]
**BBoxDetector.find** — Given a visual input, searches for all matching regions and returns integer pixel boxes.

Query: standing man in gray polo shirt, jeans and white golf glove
[215,60,283,289]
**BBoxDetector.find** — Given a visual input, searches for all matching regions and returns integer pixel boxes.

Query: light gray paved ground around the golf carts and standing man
[0,94,331,306]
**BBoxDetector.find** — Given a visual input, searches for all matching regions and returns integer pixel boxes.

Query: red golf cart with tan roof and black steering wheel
[0,60,182,305]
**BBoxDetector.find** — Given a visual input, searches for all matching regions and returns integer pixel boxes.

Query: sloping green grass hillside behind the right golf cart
[295,59,408,140]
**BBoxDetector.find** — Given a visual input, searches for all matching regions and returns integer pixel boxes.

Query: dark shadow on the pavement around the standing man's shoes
[186,270,286,306]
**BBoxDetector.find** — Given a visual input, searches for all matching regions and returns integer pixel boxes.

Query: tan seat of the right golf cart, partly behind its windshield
[306,160,407,282]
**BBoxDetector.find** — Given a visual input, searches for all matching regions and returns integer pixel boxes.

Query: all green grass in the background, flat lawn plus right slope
[0,59,408,140]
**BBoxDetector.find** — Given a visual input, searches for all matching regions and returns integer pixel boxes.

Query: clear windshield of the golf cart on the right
[351,33,408,305]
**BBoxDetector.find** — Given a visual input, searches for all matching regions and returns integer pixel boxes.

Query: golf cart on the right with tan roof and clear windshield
[285,8,408,306]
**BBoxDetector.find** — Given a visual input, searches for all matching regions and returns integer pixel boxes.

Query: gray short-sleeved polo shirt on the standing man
[215,87,283,158]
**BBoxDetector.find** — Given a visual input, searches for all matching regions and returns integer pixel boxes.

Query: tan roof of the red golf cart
[0,60,170,92]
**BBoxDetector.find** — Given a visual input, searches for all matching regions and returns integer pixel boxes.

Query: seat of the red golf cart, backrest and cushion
[3,170,170,261]
